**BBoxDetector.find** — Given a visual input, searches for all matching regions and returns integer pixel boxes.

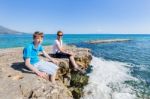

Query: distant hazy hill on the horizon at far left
[0,26,22,34]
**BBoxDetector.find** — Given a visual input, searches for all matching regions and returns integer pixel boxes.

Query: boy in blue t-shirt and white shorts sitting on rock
[23,32,58,83]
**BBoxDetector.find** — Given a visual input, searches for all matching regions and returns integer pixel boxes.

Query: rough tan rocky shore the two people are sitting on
[0,46,92,99]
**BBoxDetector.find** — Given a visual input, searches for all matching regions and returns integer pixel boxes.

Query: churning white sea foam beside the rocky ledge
[81,57,137,99]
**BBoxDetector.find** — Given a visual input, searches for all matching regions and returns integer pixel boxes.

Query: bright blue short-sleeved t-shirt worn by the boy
[23,43,44,65]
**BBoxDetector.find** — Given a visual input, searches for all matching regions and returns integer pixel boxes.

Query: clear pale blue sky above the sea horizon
[0,0,150,34]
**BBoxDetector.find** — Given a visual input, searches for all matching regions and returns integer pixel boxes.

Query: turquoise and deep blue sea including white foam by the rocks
[0,34,150,99]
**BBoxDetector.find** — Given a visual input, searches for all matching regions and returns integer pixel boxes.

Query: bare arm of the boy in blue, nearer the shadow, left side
[25,58,46,78]
